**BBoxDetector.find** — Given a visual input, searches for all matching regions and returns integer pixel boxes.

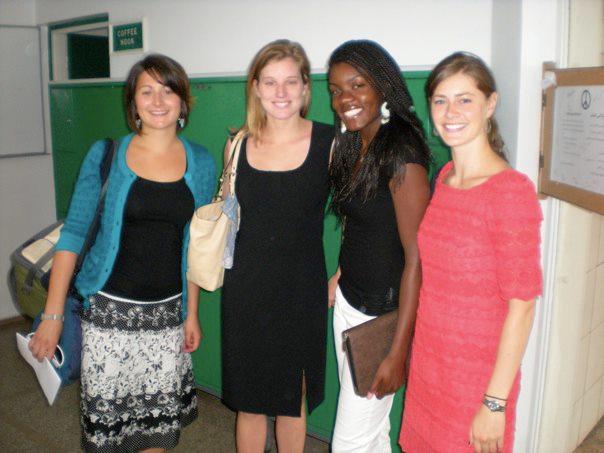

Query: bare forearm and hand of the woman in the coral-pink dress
[470,299,535,452]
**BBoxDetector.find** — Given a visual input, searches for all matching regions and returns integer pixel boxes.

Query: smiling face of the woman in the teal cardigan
[134,71,182,131]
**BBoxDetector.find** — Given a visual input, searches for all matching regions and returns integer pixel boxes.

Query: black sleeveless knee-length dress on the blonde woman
[222,122,333,416]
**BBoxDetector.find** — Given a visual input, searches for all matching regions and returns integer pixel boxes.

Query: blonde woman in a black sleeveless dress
[222,40,333,452]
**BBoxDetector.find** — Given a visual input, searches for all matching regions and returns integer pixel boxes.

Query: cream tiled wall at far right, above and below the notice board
[538,0,604,453]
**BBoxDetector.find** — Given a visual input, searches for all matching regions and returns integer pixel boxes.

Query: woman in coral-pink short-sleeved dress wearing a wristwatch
[400,52,542,453]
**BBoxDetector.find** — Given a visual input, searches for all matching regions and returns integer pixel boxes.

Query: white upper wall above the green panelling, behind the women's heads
[37,0,491,77]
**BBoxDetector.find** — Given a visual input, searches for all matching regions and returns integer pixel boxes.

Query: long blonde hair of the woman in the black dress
[242,39,311,141]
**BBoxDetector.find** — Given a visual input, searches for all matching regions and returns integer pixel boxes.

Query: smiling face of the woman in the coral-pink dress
[430,72,497,148]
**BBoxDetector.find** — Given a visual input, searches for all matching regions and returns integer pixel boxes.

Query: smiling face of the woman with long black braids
[329,63,383,138]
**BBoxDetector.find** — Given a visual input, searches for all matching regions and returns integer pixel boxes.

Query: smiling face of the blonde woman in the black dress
[254,58,307,120]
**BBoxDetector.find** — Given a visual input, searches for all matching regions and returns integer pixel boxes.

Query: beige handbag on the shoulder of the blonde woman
[187,133,243,291]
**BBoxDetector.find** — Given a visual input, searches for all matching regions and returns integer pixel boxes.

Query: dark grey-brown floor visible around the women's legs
[0,320,604,453]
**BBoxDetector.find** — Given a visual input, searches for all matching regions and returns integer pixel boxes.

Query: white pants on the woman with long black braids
[331,287,394,453]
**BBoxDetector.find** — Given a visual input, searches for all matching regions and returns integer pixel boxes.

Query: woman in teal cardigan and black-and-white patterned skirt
[30,55,216,452]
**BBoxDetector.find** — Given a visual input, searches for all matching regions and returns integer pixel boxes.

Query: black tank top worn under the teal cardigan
[103,177,195,300]
